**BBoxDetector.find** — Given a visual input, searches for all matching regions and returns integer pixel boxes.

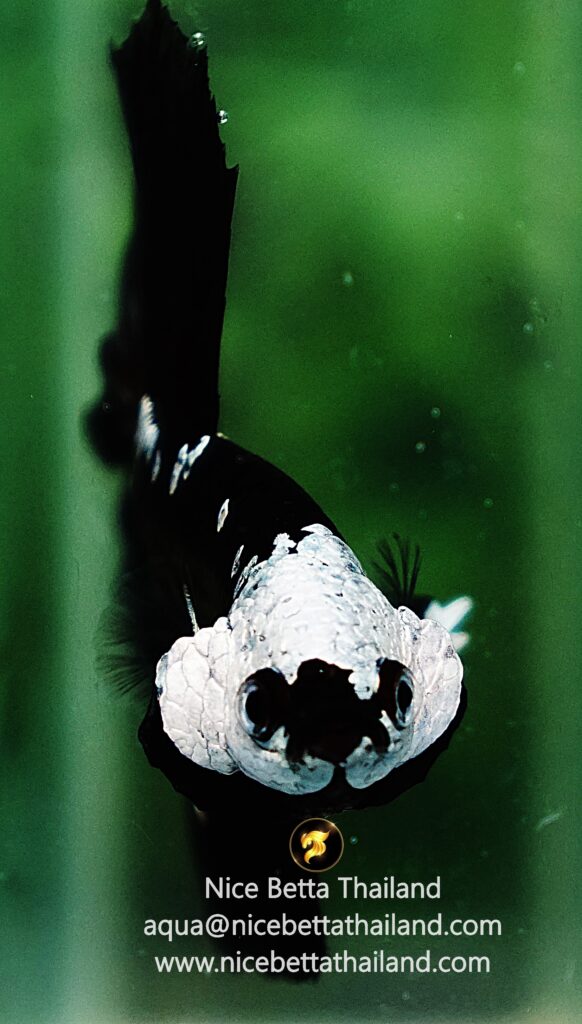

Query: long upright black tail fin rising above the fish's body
[88,0,237,464]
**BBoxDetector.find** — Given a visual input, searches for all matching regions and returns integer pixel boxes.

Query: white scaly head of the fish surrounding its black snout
[156,524,466,795]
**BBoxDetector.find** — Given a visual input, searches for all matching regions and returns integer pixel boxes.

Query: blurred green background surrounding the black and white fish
[0,0,582,1024]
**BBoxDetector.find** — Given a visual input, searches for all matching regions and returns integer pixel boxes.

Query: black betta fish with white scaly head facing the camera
[88,0,470,820]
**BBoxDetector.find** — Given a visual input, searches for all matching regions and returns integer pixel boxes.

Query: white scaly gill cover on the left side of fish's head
[156,618,238,775]
